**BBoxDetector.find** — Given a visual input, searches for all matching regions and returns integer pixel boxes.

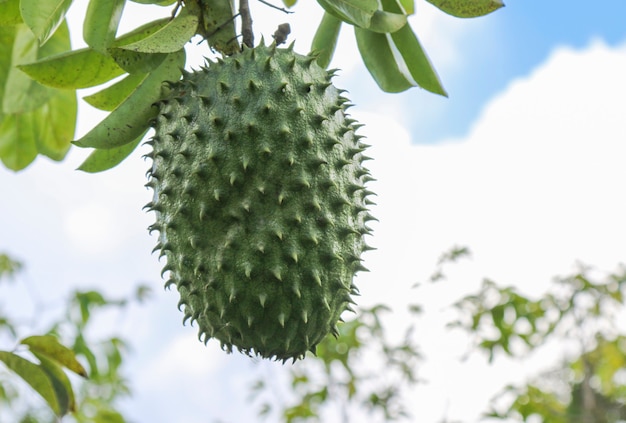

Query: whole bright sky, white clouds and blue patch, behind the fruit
[0,0,626,423]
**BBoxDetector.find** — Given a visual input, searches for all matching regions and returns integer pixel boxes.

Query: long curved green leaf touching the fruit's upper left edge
[74,50,185,148]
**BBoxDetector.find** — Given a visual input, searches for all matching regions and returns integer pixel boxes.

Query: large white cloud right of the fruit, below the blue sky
[348,42,626,421]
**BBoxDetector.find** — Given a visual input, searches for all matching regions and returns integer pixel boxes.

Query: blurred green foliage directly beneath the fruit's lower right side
[252,305,421,423]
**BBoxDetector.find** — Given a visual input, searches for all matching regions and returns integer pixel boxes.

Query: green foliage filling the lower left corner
[0,255,149,423]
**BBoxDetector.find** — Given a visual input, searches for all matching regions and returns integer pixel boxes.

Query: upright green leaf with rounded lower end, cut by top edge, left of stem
[83,0,126,53]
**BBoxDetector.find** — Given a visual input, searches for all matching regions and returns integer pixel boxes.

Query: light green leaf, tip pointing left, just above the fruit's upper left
[117,8,198,53]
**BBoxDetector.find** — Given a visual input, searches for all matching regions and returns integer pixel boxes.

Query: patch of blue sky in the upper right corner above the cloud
[346,0,626,144]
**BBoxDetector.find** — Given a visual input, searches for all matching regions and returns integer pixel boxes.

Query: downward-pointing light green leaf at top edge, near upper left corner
[20,0,72,45]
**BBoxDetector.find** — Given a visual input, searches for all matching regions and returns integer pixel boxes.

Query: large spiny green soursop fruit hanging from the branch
[148,44,373,361]
